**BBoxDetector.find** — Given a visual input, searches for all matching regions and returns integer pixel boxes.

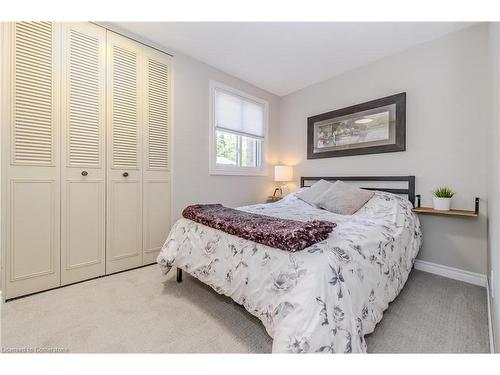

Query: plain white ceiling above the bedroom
[111,22,472,96]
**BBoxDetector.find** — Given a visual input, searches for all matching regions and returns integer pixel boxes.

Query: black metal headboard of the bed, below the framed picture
[300,176,415,206]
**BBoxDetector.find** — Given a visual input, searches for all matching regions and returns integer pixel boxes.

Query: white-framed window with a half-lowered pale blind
[210,81,268,176]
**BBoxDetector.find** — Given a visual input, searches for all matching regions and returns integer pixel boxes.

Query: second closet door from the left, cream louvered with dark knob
[61,22,106,285]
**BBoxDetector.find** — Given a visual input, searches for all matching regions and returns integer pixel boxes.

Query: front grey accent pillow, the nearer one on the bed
[316,181,375,215]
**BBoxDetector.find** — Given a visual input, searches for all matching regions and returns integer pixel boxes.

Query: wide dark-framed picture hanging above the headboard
[307,92,406,159]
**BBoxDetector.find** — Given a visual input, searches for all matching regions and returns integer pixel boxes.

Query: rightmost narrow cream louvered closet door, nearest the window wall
[142,47,172,264]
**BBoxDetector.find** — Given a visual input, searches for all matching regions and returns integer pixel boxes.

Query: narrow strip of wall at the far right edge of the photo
[488,22,500,352]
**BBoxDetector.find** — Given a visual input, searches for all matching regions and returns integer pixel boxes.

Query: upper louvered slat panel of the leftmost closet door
[11,22,57,167]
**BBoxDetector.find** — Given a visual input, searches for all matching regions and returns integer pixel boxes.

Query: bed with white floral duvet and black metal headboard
[158,176,422,353]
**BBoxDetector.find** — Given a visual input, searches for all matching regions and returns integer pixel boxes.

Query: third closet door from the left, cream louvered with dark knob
[106,31,142,274]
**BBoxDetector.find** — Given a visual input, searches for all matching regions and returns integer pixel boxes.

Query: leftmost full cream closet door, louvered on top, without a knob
[2,22,60,298]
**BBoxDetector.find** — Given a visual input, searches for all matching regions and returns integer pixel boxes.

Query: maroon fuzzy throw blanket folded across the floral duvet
[182,204,337,252]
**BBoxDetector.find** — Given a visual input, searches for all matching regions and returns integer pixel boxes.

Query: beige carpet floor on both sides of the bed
[1,266,488,353]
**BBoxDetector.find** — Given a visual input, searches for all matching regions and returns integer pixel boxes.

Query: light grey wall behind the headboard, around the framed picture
[280,24,490,277]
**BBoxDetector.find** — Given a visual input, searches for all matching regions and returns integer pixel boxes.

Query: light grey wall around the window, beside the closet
[173,53,279,219]
